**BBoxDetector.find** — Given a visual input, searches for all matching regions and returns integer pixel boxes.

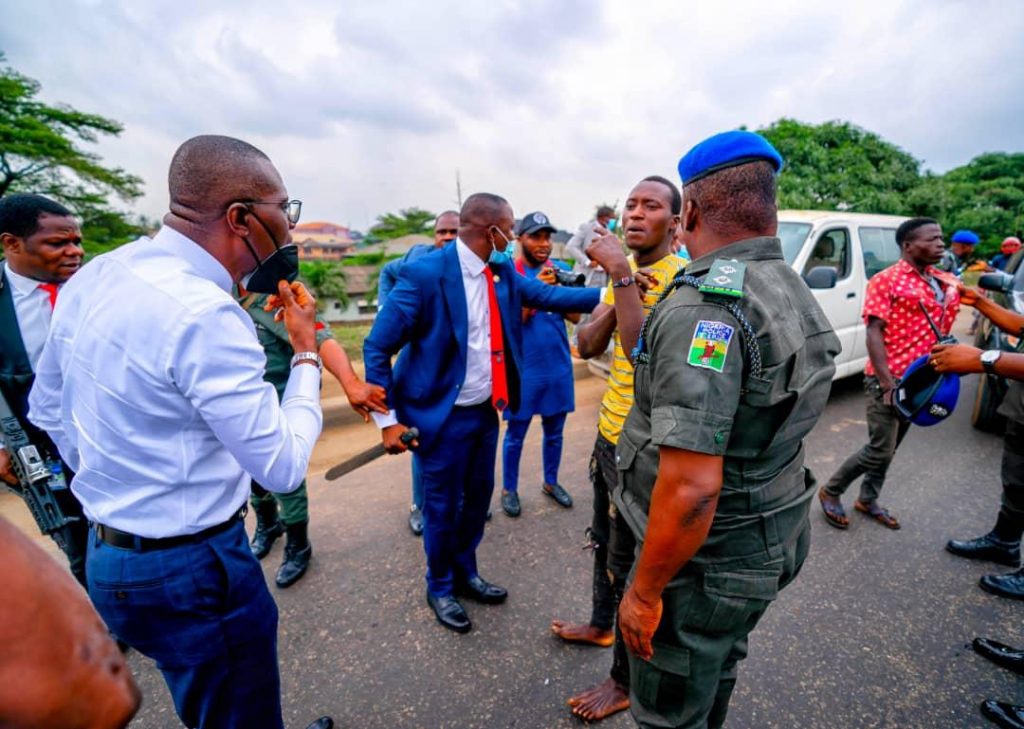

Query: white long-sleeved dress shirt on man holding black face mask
[29,227,322,538]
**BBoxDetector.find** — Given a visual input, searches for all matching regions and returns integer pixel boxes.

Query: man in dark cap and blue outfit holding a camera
[502,212,580,517]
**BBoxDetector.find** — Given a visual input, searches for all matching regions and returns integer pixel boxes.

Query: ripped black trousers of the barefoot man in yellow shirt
[590,433,636,687]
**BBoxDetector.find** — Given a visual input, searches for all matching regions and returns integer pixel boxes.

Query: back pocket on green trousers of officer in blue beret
[684,568,779,635]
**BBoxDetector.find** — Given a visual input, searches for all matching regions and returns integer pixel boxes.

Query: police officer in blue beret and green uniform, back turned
[588,131,840,727]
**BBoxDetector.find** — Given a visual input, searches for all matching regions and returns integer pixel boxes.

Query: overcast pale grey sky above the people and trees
[0,0,1024,229]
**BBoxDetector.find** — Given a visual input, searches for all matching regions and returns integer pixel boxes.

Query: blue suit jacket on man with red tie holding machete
[362,245,601,448]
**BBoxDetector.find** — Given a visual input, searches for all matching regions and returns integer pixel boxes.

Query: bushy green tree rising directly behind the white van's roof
[758,119,921,214]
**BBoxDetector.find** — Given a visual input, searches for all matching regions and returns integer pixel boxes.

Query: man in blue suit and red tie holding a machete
[364,192,600,633]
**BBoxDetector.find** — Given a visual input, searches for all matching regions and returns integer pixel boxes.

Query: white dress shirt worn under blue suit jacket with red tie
[370,239,490,429]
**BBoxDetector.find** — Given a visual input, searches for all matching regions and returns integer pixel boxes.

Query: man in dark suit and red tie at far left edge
[0,195,89,587]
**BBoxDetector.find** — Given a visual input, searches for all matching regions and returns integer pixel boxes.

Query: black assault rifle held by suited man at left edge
[0,392,78,553]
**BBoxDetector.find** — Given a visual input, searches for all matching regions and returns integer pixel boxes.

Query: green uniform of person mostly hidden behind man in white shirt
[232,289,334,525]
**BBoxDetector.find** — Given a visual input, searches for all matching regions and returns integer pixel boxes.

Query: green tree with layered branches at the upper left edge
[0,53,142,247]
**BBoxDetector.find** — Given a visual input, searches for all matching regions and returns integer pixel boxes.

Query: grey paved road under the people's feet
[6,337,1024,729]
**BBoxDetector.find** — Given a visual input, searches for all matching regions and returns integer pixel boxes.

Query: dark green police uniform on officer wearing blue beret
[614,238,840,727]
